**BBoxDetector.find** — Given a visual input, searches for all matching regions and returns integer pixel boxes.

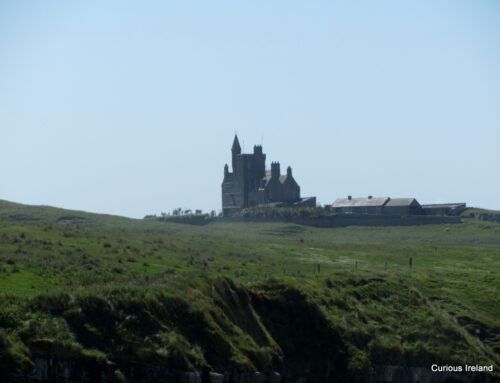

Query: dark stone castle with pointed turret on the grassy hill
[222,135,316,213]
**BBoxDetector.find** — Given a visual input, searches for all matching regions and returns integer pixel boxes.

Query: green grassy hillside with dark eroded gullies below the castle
[0,201,500,381]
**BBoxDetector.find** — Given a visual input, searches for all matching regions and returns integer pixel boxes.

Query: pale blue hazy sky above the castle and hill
[0,0,500,217]
